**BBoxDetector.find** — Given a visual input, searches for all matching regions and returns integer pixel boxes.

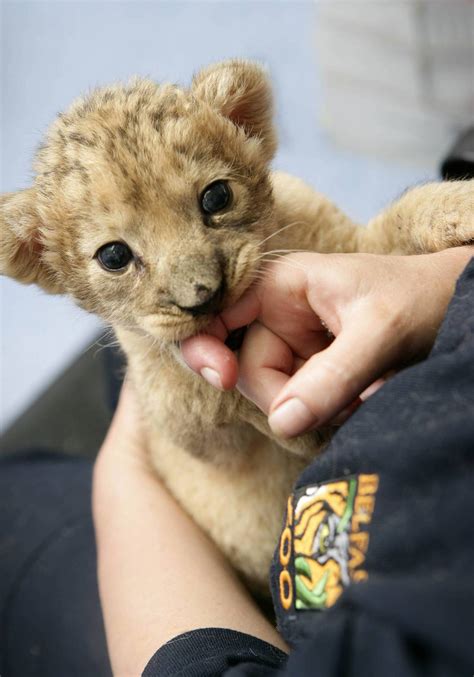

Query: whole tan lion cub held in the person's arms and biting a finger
[0,61,473,589]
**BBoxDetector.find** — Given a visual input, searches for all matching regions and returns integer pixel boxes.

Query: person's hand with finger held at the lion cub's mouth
[181,246,473,437]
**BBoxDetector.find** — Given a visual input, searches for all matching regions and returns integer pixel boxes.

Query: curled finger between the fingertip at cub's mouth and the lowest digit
[237,322,294,414]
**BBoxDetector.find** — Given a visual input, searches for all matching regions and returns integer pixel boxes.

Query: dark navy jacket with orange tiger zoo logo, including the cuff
[143,259,474,677]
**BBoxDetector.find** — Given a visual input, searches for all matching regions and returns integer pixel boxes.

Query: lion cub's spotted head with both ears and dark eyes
[0,61,275,340]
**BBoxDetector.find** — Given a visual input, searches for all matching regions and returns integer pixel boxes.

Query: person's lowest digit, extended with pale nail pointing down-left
[269,316,398,437]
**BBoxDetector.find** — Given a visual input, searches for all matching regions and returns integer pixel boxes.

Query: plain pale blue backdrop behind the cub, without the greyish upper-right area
[0,0,432,426]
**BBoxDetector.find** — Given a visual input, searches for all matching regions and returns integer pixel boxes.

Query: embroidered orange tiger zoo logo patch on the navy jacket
[279,474,379,611]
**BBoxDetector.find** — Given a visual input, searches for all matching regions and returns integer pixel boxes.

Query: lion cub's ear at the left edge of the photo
[0,188,63,294]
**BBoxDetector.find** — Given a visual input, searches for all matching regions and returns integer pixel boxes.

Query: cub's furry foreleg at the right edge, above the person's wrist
[358,181,474,254]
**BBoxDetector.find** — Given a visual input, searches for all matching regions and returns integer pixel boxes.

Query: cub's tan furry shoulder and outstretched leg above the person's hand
[270,173,474,254]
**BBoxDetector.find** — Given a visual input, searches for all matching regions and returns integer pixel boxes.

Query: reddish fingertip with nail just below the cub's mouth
[181,334,239,390]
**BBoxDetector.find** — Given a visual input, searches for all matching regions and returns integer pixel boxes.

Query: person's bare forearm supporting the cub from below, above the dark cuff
[93,384,286,677]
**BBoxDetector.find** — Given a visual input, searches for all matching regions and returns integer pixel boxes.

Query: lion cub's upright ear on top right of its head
[191,60,276,160]
